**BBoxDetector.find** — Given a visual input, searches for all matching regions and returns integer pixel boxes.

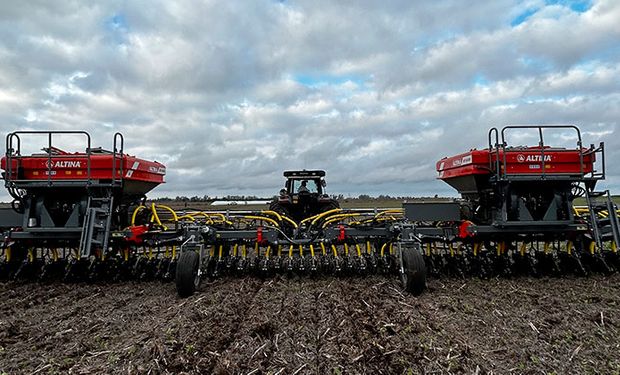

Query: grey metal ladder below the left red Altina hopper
[80,197,114,258]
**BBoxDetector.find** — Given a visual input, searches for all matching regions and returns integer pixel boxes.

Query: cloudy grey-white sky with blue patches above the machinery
[0,0,620,197]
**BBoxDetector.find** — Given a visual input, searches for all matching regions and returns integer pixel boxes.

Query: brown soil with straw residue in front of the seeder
[0,275,620,374]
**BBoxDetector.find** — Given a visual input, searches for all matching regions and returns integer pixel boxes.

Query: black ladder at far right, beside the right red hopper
[586,190,620,250]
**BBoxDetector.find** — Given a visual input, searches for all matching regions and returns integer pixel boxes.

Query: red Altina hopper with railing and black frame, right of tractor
[436,125,605,229]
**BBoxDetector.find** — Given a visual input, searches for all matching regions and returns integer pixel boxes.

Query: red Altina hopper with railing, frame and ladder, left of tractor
[0,131,166,259]
